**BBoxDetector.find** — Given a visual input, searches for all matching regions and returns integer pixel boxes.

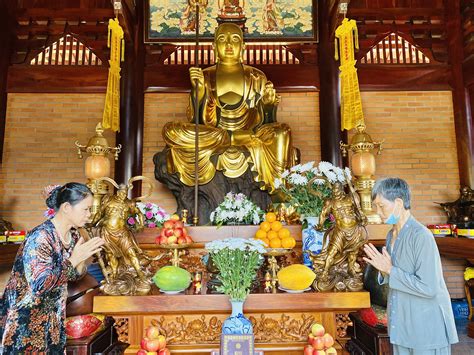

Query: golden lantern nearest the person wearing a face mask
[340,125,384,224]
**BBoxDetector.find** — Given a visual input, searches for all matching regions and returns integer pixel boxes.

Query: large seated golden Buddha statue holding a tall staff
[163,23,297,193]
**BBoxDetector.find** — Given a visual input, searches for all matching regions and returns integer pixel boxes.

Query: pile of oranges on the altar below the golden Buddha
[255,212,296,249]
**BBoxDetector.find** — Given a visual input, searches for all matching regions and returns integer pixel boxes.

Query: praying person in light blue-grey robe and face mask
[364,178,458,355]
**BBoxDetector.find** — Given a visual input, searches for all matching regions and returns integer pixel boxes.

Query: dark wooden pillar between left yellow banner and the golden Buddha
[115,1,145,197]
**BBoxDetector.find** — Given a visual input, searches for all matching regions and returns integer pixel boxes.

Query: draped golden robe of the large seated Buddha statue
[163,65,297,192]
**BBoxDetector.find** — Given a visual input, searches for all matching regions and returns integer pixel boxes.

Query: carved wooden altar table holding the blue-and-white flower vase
[94,290,370,355]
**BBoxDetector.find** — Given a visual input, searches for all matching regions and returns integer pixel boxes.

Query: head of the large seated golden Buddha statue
[214,23,245,64]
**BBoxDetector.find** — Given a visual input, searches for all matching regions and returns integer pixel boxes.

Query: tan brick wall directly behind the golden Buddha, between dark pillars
[143,92,321,213]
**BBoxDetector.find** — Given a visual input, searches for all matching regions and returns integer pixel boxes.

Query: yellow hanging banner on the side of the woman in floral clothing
[102,18,125,132]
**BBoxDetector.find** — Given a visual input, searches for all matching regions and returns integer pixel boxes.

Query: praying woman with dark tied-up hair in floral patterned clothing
[0,182,103,354]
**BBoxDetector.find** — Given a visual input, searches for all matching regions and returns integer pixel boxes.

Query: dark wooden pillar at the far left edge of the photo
[0,2,13,163]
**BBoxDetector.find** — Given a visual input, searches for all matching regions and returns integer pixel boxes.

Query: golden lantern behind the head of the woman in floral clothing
[75,122,122,216]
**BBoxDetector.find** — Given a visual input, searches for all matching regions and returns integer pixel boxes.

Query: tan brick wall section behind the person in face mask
[362,91,459,224]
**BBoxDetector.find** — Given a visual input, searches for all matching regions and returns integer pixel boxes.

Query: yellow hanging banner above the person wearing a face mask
[335,18,364,131]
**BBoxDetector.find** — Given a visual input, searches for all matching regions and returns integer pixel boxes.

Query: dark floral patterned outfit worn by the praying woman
[0,220,79,354]
